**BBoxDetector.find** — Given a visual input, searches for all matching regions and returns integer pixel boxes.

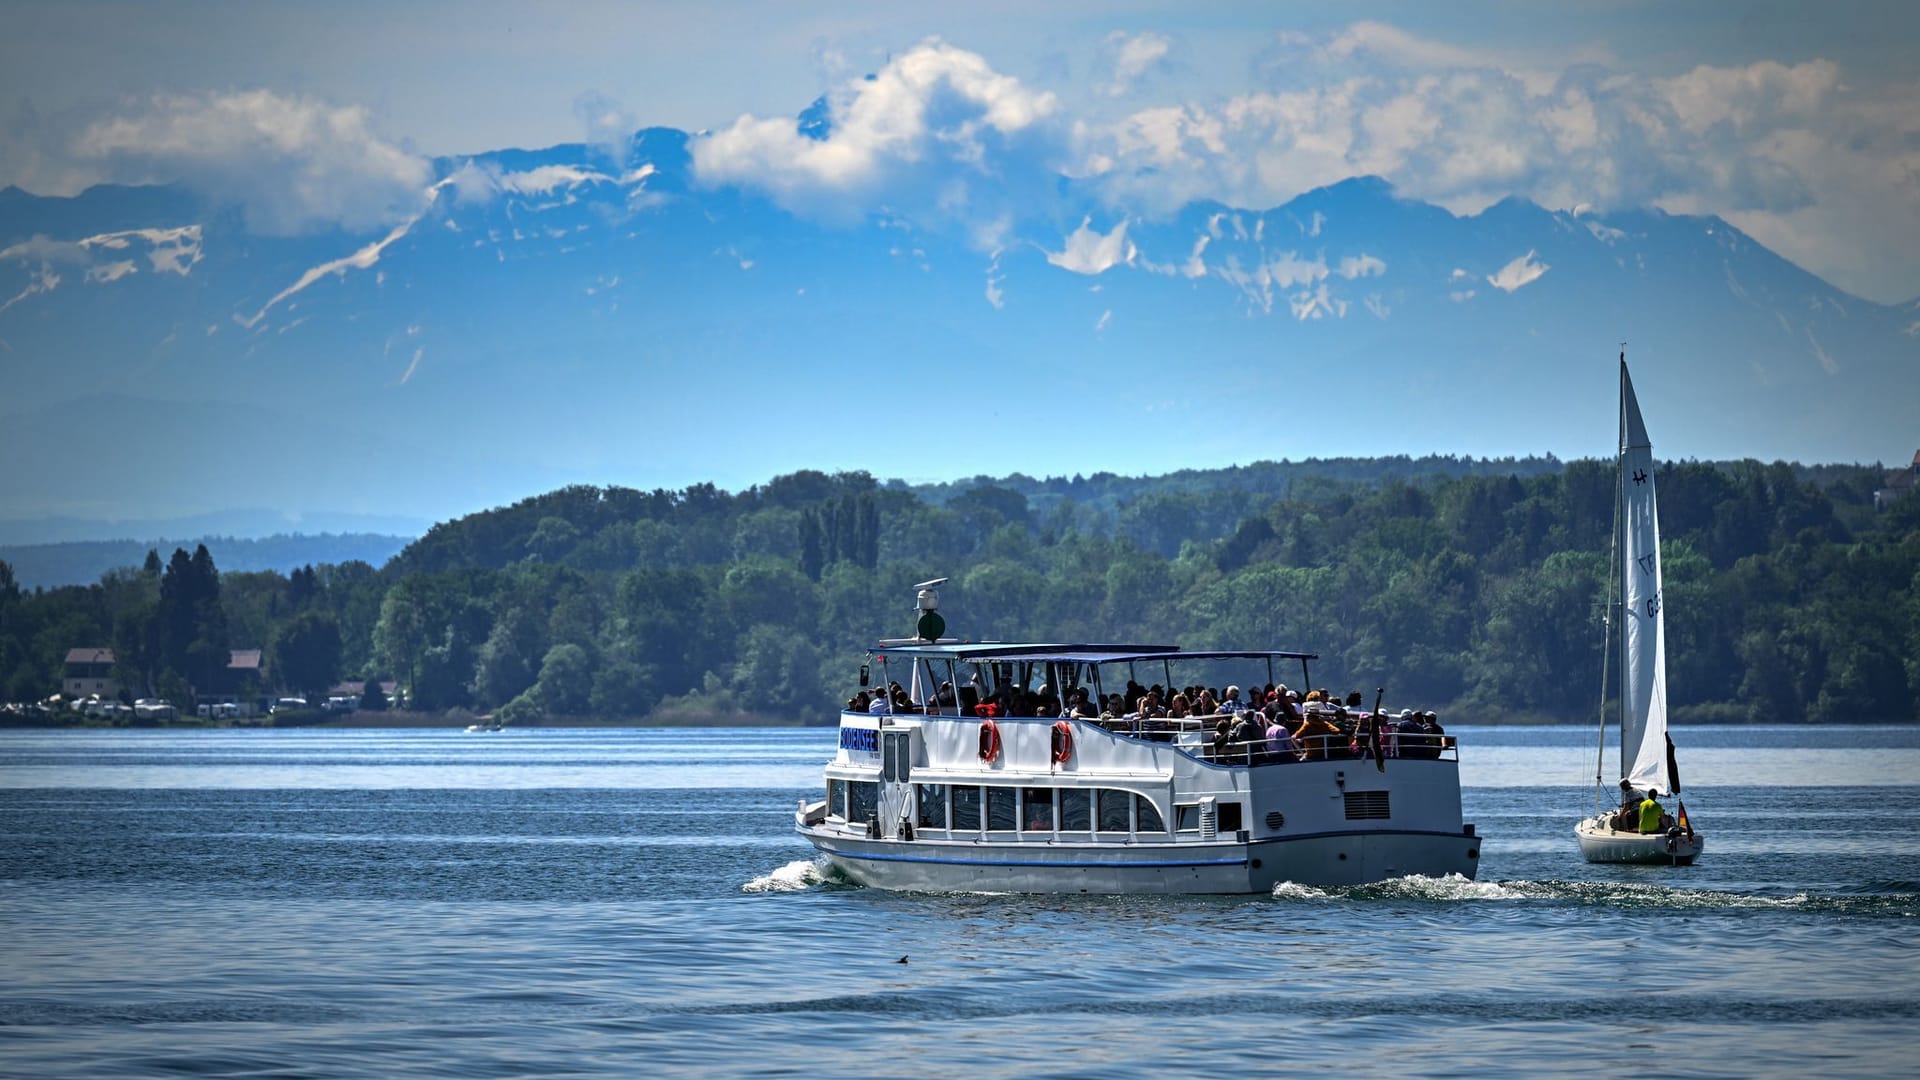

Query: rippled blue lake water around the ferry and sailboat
[0,726,1920,1078]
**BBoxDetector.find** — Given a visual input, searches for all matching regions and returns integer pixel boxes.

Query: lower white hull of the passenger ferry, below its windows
[801,826,1480,894]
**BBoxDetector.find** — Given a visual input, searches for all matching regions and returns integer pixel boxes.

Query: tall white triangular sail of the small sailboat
[1620,356,1674,794]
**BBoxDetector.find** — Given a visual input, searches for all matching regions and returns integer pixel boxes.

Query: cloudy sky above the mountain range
[11,0,1920,302]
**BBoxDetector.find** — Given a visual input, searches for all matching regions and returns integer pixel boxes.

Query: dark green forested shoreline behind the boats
[0,457,1920,723]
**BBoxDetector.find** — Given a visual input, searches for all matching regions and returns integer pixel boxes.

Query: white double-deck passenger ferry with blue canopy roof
[795,578,1480,894]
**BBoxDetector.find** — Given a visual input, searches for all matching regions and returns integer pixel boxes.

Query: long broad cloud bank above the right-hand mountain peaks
[1073,23,1920,302]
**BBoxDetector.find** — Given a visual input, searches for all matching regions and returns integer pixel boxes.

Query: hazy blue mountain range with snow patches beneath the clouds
[0,115,1920,519]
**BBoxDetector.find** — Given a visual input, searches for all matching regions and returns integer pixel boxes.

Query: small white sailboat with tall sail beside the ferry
[1574,352,1707,867]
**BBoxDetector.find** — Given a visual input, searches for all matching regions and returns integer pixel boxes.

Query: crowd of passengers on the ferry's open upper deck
[847,680,1452,765]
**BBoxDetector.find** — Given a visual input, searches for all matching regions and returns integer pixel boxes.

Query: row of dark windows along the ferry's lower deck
[828,780,1242,832]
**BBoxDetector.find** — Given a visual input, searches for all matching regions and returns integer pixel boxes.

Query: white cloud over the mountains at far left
[73,90,432,234]
